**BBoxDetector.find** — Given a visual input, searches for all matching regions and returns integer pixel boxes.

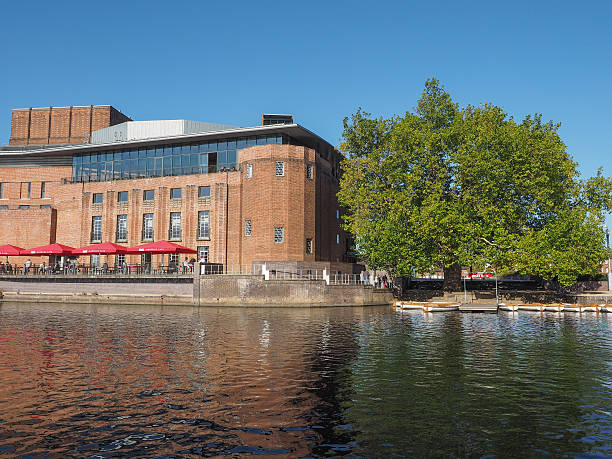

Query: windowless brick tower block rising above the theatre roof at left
[9,105,130,145]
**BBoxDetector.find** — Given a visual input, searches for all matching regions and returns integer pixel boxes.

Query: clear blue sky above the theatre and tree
[0,0,612,181]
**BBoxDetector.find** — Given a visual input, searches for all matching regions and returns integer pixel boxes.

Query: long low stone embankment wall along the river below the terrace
[0,275,393,307]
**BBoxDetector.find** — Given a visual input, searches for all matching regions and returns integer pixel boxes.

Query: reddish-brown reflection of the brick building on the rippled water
[0,303,362,456]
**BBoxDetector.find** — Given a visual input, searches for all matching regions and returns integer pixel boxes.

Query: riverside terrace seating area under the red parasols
[0,241,197,276]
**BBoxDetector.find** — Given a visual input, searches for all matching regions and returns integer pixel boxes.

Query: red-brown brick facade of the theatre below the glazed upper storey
[0,143,347,266]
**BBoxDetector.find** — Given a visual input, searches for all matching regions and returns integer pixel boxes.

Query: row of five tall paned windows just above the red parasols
[91,210,210,242]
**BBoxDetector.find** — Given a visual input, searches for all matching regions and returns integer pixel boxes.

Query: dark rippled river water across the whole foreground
[0,303,612,457]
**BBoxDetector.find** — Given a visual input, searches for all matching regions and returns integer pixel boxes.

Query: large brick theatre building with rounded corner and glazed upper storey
[0,106,352,272]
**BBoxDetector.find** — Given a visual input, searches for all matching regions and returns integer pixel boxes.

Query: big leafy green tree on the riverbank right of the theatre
[338,79,612,290]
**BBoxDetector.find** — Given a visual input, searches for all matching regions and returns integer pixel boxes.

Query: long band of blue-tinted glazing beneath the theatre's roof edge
[72,135,290,182]
